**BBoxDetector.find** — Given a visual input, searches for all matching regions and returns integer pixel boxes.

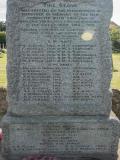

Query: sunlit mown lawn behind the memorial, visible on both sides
[0,54,120,89]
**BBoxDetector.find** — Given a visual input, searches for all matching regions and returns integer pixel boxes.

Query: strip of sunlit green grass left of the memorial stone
[0,54,7,88]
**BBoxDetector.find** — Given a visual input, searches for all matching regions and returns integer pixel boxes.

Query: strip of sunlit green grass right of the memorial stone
[111,53,120,89]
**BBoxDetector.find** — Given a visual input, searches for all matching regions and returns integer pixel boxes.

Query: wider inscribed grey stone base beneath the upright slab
[2,115,120,160]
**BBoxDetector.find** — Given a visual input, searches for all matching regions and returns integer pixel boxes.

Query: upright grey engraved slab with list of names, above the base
[7,0,112,115]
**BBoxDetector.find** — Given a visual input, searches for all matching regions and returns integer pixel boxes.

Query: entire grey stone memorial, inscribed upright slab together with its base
[3,0,120,160]
